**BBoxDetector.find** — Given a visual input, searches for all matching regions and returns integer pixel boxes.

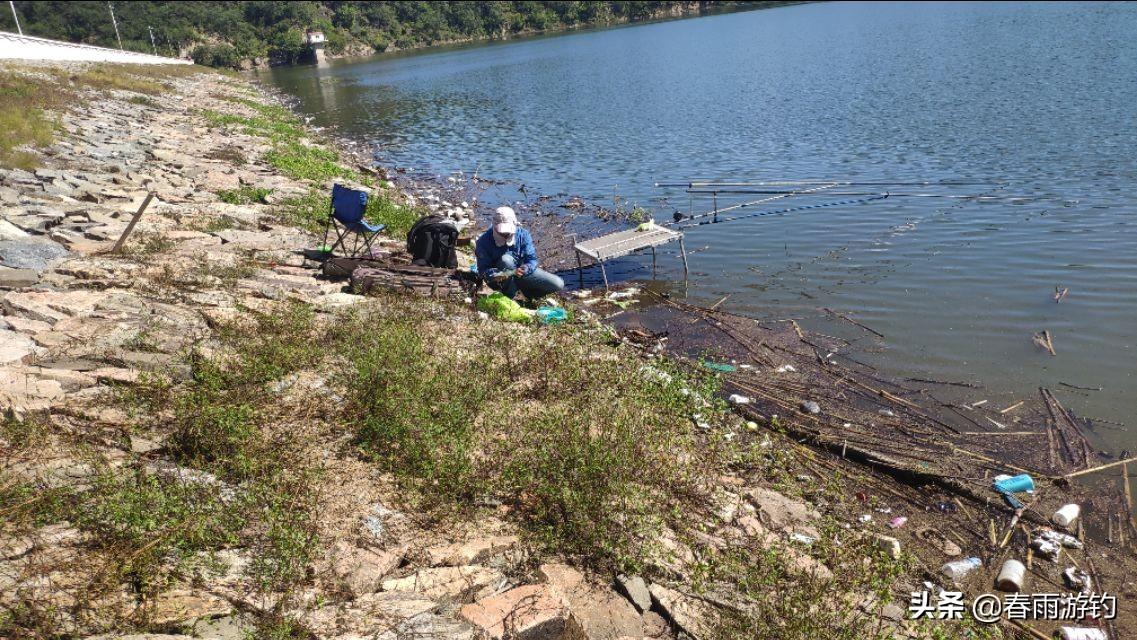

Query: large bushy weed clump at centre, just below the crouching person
[338,299,721,570]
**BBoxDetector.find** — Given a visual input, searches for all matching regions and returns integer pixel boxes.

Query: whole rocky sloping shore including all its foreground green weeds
[0,61,1132,640]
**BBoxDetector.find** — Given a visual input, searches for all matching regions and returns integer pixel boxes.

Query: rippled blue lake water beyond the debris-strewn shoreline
[265,2,1137,454]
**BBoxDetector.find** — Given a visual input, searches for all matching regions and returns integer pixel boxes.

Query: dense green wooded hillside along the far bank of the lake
[0,1,789,67]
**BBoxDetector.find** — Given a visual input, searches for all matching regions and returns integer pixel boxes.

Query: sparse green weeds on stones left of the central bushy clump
[0,306,321,638]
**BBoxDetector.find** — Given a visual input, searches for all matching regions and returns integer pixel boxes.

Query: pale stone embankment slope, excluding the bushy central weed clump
[0,61,1050,640]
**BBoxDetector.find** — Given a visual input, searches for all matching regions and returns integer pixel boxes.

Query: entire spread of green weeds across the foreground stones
[0,294,993,640]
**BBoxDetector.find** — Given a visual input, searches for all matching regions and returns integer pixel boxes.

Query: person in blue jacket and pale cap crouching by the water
[474,207,565,300]
